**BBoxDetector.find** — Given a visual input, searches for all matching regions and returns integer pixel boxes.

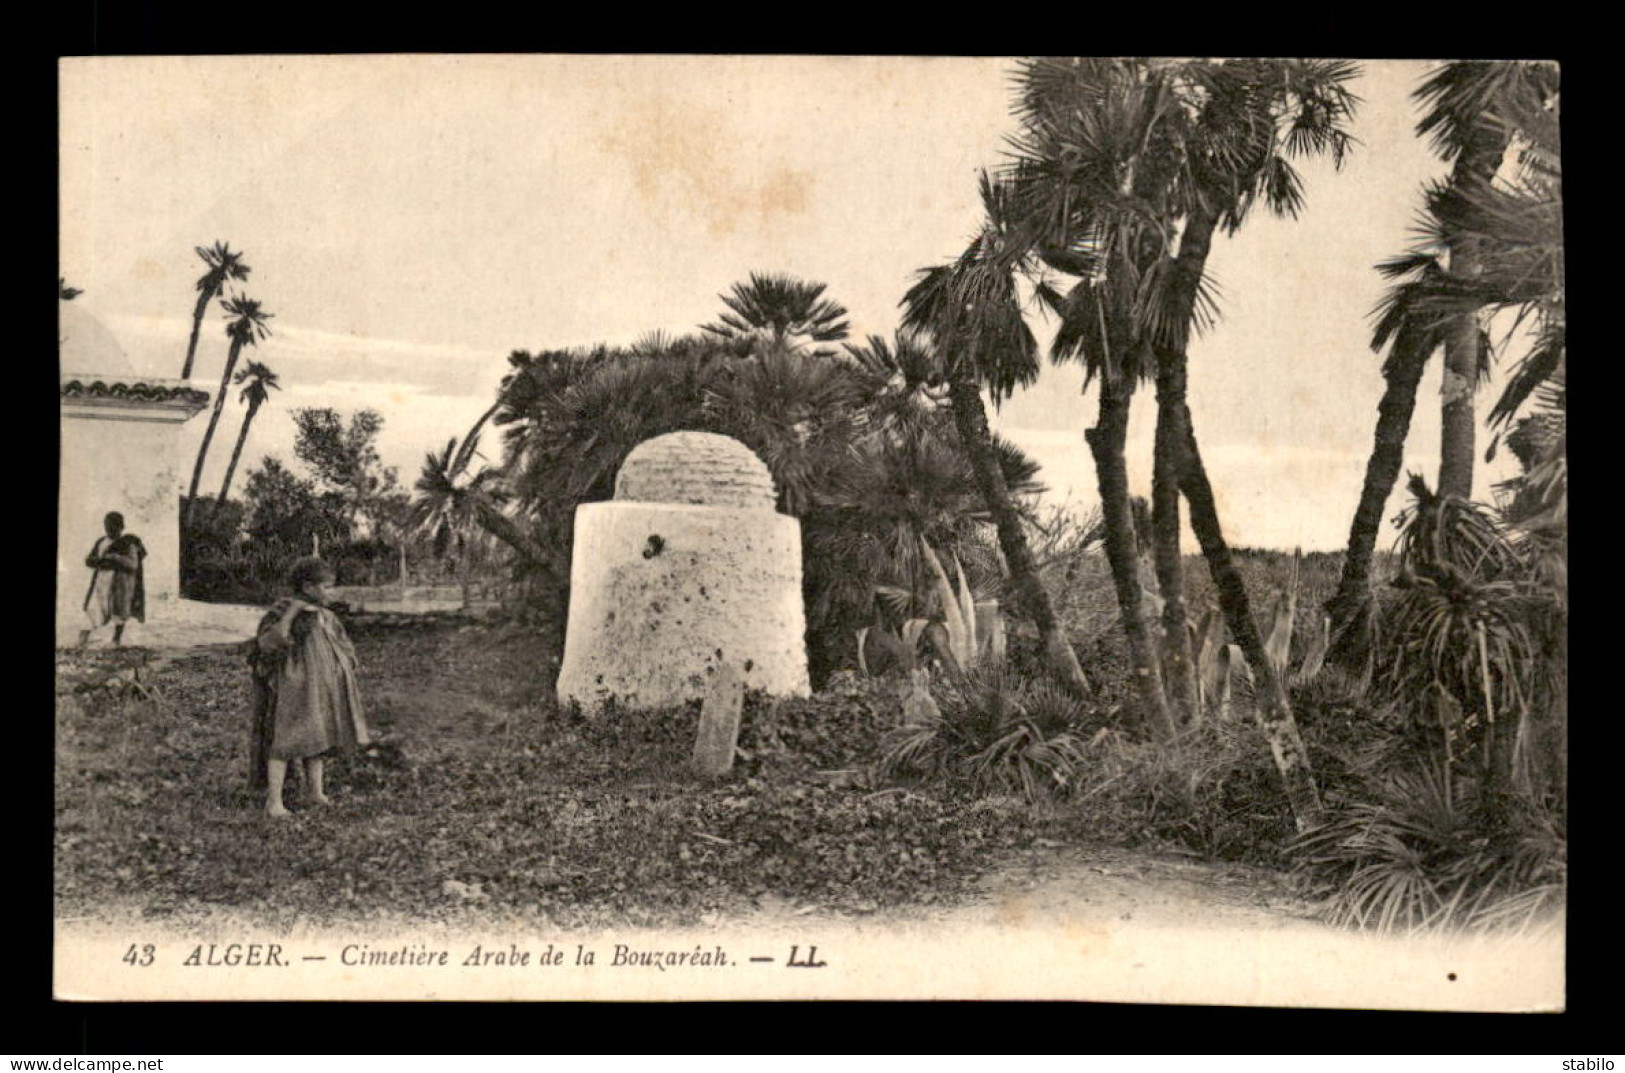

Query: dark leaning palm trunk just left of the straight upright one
[1326,325,1433,667]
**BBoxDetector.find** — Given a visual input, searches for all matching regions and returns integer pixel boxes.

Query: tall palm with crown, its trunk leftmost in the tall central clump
[1001,59,1186,738]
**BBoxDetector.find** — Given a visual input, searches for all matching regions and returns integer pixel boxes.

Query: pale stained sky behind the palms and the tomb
[60,55,1511,550]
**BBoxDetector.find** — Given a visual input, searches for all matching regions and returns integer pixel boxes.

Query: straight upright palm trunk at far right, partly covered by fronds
[1438,120,1506,499]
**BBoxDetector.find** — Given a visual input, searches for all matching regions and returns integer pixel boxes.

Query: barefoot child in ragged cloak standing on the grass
[250,558,371,816]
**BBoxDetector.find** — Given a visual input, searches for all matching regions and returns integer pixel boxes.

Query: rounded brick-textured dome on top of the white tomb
[614,432,778,510]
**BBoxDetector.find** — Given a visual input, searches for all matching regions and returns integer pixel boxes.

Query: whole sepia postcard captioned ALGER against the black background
[52,54,1568,1013]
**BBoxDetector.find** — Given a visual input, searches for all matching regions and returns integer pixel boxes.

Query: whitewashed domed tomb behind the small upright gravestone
[557,432,809,709]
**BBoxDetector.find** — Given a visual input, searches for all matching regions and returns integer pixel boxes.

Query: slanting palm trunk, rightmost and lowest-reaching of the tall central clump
[1181,411,1321,831]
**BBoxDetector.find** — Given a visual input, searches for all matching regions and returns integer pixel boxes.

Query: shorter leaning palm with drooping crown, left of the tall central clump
[904,172,1090,694]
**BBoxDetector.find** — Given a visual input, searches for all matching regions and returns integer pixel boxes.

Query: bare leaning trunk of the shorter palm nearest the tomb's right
[949,379,1090,694]
